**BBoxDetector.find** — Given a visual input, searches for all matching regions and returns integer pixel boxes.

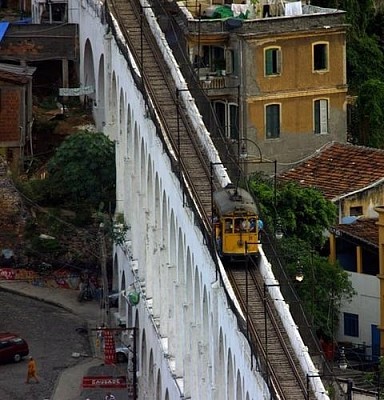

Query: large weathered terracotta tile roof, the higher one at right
[279,142,384,200]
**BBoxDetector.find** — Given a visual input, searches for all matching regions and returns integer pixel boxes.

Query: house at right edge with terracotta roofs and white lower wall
[281,143,384,361]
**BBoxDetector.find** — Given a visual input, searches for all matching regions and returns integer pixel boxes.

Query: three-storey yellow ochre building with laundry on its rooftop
[174,1,347,169]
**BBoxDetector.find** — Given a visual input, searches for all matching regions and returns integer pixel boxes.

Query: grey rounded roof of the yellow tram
[213,186,258,215]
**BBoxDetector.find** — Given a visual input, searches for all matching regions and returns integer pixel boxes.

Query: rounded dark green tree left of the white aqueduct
[47,131,116,209]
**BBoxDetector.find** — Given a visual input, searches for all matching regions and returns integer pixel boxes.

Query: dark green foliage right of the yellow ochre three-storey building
[312,0,384,148]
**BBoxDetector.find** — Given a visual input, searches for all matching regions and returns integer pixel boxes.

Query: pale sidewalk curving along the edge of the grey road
[0,280,127,400]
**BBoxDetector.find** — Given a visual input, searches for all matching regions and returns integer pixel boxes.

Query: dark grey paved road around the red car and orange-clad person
[0,290,91,400]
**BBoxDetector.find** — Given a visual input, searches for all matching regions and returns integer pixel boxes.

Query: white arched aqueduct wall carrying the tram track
[64,1,327,400]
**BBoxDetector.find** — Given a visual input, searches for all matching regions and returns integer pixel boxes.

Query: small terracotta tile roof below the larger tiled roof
[332,218,379,248]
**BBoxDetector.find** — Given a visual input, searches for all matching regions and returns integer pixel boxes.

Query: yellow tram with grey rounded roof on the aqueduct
[213,185,259,257]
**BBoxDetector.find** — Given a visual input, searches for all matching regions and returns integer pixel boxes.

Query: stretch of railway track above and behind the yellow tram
[108,0,217,228]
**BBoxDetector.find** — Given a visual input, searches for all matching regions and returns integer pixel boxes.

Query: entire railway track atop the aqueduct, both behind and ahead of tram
[107,0,312,400]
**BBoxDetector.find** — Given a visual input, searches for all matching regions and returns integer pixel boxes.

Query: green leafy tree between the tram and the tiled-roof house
[248,175,355,338]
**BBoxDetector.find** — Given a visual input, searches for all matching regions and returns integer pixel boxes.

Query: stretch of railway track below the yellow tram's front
[225,257,315,400]
